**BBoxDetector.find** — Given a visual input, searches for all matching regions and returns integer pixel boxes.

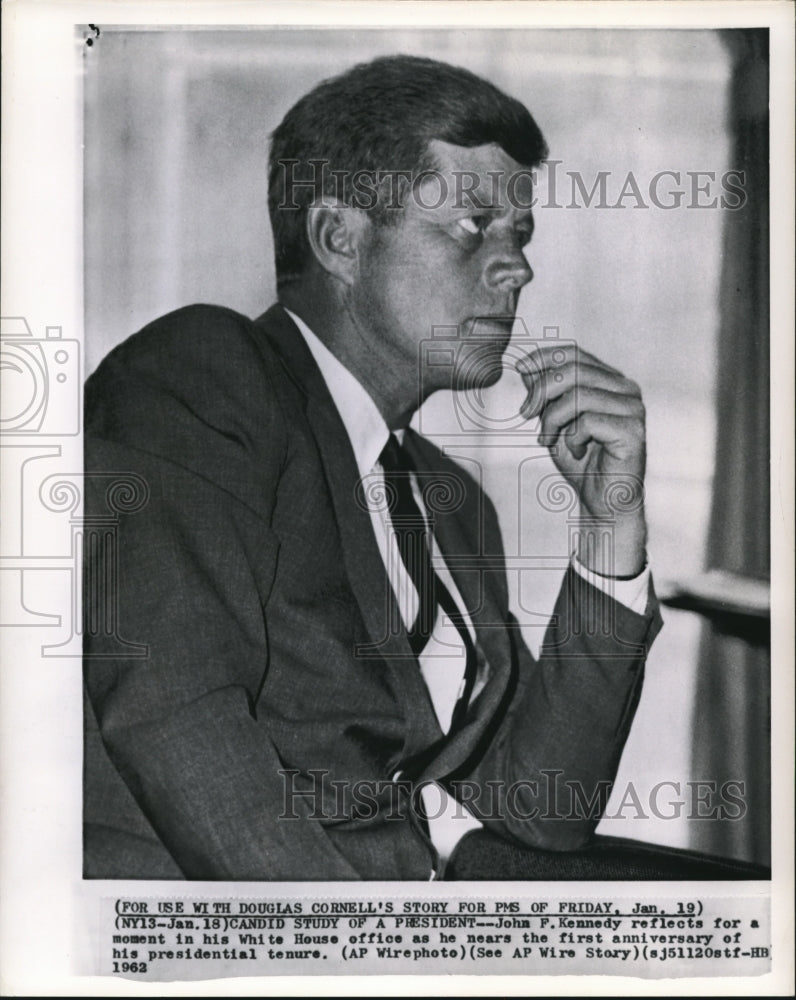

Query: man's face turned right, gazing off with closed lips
[350,140,533,396]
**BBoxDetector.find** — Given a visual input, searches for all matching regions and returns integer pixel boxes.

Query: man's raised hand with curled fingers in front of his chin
[516,343,646,577]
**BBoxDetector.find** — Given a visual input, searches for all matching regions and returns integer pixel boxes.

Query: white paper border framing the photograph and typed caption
[0,0,794,996]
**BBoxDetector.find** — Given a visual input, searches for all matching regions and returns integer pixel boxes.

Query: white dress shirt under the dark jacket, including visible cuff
[285,309,649,876]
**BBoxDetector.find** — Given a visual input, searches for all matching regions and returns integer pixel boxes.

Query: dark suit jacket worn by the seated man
[84,306,659,880]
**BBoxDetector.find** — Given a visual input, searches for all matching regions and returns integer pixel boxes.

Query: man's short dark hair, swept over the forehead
[268,55,547,284]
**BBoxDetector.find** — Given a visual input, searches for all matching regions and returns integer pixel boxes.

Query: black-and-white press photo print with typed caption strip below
[0,4,792,992]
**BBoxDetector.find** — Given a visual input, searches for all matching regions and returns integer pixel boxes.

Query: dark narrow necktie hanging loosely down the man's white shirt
[379,434,478,730]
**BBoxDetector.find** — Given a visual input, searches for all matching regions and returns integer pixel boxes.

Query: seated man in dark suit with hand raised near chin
[84,57,660,880]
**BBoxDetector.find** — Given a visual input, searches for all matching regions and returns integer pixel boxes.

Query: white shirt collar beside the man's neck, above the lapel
[283,307,390,476]
